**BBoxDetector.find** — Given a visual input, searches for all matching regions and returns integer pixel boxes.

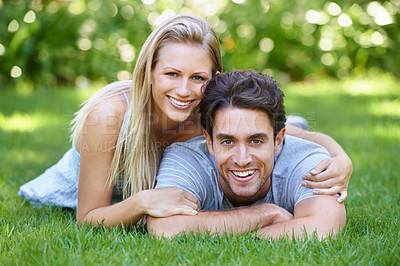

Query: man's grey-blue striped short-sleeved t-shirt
[156,136,330,213]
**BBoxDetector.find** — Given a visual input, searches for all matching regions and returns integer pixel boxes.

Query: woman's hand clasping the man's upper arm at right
[302,155,353,203]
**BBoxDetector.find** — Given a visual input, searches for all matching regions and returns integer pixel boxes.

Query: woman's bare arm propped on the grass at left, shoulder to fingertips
[77,98,198,227]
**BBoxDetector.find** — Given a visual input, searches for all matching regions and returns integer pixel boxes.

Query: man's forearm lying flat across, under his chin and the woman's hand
[147,203,293,237]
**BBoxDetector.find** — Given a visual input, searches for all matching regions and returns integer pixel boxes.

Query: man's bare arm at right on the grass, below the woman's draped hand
[258,196,346,239]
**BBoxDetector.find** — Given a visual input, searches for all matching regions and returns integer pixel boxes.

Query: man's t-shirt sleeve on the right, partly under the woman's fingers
[289,148,330,208]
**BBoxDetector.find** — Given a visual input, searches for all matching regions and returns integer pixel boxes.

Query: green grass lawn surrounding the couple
[0,75,400,265]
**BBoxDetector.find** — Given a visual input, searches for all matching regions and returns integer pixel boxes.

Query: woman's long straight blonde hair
[71,15,222,202]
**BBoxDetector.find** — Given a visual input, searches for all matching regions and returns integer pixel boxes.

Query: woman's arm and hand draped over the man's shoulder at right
[286,125,353,203]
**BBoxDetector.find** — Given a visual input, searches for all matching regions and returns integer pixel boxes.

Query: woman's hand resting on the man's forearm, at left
[140,187,200,217]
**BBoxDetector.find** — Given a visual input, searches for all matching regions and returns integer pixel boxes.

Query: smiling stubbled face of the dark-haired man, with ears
[204,107,285,206]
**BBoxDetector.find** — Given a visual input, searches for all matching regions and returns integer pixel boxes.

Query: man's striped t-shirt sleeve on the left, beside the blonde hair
[156,144,213,208]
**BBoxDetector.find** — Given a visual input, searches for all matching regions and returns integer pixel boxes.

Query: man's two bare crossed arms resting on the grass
[147,196,346,239]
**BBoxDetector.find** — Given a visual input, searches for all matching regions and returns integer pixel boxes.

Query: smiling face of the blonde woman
[151,43,212,123]
